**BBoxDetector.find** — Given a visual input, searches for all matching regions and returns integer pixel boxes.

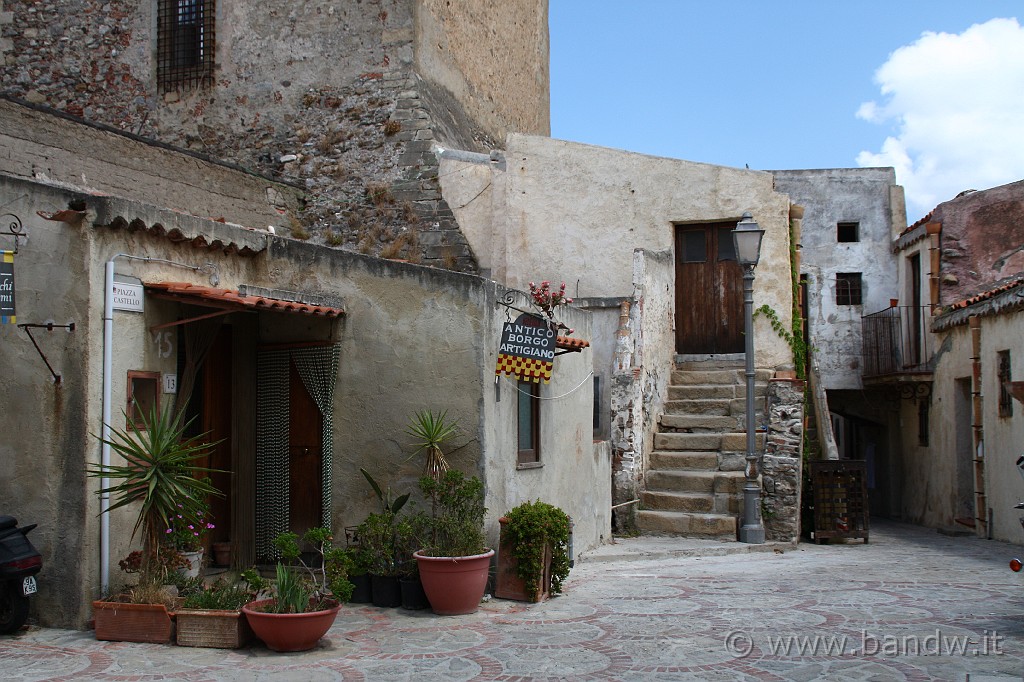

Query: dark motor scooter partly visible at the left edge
[0,516,43,635]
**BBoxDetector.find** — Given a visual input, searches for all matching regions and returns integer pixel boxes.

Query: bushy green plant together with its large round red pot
[414,470,495,615]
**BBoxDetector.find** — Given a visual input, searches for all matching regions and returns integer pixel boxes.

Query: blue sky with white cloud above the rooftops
[549,0,1024,222]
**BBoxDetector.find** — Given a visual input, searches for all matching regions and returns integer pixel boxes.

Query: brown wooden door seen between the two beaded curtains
[288,365,324,536]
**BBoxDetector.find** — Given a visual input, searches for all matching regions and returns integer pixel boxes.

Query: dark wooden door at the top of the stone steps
[676,222,743,353]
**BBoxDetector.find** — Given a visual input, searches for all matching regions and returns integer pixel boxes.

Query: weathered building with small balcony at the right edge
[865,181,1024,543]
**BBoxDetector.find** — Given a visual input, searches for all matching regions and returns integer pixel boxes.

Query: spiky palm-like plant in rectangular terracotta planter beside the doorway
[86,409,220,642]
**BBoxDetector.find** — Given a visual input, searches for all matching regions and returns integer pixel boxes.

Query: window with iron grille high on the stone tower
[157,0,216,92]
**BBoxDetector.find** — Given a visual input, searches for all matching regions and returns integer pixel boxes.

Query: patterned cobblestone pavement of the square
[0,523,1024,682]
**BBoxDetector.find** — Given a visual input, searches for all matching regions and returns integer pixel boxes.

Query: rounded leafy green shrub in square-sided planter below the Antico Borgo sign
[495,500,571,601]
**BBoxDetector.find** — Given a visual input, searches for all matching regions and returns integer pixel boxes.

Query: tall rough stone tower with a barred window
[0,0,550,271]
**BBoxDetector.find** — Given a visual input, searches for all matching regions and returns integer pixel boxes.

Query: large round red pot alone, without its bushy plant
[413,550,495,615]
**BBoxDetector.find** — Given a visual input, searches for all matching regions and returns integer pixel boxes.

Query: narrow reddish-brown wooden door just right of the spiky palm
[201,325,233,543]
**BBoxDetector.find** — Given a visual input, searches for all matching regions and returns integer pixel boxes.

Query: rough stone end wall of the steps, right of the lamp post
[761,379,804,542]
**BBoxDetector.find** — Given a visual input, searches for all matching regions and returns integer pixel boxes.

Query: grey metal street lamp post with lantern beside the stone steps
[732,213,765,545]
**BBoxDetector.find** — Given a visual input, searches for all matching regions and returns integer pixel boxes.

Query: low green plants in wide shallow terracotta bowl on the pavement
[242,527,353,651]
